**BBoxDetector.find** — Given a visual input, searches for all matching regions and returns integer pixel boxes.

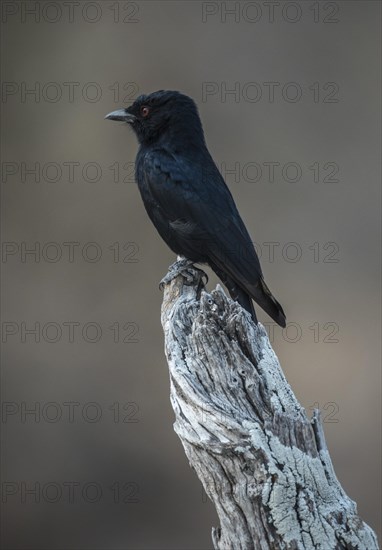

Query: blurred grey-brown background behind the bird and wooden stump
[1,1,381,550]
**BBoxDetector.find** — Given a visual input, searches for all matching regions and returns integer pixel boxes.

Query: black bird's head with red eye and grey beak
[105,90,204,145]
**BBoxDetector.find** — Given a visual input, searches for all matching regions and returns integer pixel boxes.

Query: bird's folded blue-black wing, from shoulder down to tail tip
[138,148,285,322]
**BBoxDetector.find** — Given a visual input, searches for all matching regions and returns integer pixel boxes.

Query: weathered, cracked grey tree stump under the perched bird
[162,271,379,550]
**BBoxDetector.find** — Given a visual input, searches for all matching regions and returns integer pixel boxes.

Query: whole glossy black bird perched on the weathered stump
[106,90,285,327]
